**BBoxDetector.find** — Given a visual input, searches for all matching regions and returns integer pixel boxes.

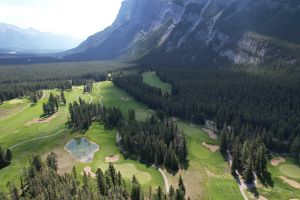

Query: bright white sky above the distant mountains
[0,0,122,40]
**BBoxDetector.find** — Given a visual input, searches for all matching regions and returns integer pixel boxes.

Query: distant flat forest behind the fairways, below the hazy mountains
[0,61,130,103]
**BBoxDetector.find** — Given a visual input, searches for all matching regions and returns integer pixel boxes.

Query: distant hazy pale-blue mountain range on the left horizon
[0,23,79,52]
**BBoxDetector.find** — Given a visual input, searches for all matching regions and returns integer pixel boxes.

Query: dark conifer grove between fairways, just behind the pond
[69,98,123,129]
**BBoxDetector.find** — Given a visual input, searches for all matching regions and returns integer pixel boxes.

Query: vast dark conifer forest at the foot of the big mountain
[113,68,300,152]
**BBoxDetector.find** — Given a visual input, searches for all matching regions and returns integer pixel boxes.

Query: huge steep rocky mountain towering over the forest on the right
[64,0,300,64]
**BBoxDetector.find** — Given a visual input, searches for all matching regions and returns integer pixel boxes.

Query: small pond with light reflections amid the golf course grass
[65,137,99,163]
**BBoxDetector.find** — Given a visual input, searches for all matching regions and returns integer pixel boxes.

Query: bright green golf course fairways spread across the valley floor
[0,78,300,200]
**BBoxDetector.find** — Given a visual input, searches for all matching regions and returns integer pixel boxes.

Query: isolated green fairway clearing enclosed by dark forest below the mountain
[143,72,172,93]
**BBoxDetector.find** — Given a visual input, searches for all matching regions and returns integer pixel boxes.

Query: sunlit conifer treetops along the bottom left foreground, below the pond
[0,153,189,200]
